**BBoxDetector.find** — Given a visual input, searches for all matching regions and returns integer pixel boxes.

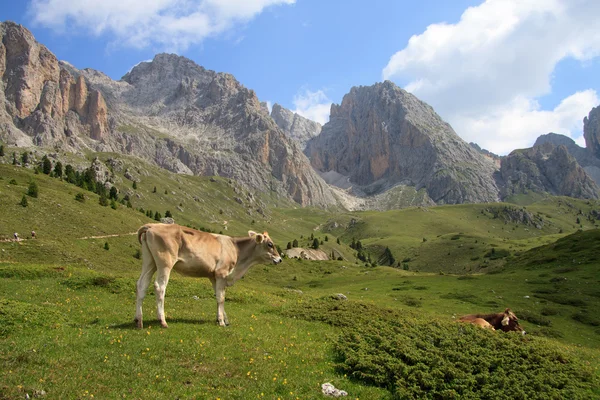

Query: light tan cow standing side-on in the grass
[135,224,281,328]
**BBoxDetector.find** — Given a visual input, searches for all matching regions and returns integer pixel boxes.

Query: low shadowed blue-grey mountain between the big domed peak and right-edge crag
[500,143,598,199]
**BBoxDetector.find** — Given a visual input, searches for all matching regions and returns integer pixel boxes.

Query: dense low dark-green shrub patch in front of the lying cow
[282,298,600,399]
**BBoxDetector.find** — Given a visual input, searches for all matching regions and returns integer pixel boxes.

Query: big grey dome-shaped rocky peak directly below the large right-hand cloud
[305,81,499,204]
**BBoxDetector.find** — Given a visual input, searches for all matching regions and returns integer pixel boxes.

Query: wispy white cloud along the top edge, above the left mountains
[29,0,295,51]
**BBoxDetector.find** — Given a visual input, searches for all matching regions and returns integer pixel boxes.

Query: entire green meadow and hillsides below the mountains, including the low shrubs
[0,156,600,399]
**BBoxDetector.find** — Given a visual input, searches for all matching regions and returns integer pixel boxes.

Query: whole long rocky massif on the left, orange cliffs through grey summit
[0,22,337,206]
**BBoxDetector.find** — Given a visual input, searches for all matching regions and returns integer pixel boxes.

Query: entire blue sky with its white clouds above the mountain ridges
[0,0,600,154]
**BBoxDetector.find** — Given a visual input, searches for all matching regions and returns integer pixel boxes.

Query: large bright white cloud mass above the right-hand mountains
[383,0,600,154]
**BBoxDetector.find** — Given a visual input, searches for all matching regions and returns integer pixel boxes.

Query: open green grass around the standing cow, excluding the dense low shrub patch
[0,158,600,398]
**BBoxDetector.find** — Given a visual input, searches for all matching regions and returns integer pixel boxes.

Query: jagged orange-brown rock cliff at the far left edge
[0,22,109,149]
